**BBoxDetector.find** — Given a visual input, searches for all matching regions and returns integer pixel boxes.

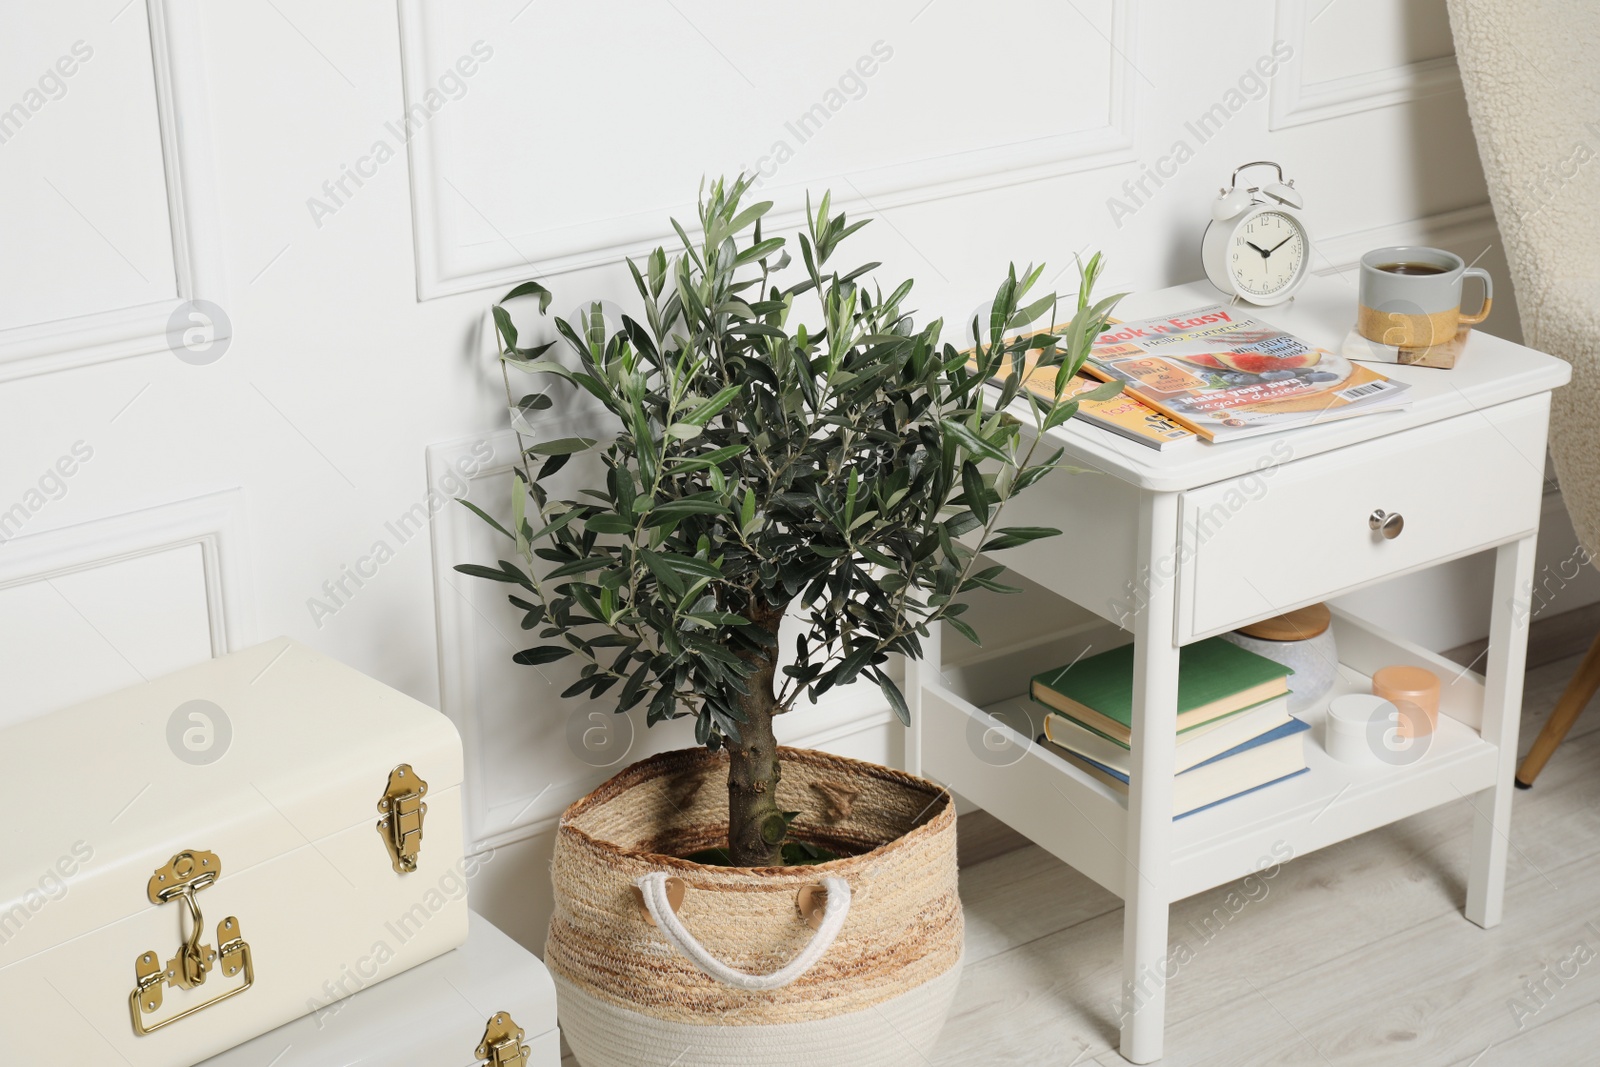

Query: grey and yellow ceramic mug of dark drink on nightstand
[1357,246,1494,349]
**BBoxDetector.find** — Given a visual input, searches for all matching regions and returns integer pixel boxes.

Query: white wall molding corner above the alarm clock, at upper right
[1267,0,1461,130]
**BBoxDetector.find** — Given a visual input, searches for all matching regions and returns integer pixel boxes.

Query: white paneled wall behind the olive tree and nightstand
[0,0,1594,944]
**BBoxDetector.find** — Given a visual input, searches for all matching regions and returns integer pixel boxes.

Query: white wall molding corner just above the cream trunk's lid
[0,488,256,656]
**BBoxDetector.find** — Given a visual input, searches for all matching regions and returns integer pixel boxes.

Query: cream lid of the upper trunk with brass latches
[0,638,461,968]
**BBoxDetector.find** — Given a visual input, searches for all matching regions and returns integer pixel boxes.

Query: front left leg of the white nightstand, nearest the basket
[1120,493,1178,1064]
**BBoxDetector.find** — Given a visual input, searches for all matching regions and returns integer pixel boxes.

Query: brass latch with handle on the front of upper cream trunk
[128,849,256,1035]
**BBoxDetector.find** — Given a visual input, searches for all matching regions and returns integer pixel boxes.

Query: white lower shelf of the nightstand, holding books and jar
[923,614,1499,899]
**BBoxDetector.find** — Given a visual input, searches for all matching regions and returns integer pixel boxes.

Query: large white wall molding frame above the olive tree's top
[400,0,1142,301]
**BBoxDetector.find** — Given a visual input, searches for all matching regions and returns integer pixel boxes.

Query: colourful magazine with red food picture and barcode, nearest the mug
[1085,304,1410,442]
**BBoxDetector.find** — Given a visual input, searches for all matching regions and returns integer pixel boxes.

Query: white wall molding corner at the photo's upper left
[0,0,227,382]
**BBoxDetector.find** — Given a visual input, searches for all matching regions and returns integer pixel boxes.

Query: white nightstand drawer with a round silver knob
[1176,395,1549,641]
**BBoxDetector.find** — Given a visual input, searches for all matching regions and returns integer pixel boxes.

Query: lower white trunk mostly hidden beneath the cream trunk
[205,913,562,1067]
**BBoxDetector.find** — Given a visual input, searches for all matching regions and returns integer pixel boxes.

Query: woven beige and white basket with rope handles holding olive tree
[544,749,962,1067]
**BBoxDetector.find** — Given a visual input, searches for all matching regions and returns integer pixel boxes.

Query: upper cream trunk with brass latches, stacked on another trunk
[0,638,467,1067]
